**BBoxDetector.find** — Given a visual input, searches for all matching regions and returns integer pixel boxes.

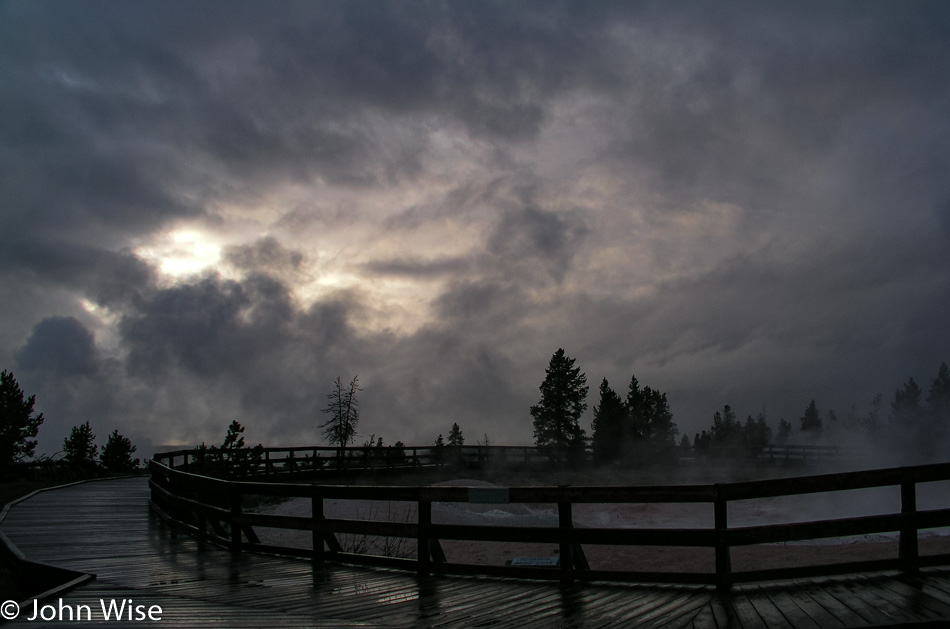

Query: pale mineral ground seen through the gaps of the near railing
[247,479,950,572]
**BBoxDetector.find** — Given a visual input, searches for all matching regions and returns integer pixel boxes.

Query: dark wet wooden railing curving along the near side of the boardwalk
[150,452,950,588]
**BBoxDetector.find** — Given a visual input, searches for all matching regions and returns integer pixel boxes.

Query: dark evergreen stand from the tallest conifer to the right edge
[529,348,950,465]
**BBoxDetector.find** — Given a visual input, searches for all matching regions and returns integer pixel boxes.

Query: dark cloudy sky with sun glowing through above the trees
[0,0,950,454]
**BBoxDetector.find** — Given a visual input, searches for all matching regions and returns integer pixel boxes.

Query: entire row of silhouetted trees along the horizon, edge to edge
[0,356,950,477]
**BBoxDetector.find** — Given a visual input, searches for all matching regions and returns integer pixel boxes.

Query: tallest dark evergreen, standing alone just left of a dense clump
[530,348,588,448]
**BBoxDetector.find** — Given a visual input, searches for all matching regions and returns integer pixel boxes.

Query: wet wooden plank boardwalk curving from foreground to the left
[0,478,950,629]
